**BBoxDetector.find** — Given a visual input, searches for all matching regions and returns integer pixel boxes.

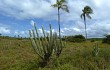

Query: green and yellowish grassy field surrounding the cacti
[0,39,110,70]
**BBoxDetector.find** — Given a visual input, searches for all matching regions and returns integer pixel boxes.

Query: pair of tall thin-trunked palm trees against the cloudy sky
[51,0,93,39]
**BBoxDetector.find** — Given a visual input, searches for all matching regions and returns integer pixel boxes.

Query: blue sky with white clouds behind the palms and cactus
[0,0,110,38]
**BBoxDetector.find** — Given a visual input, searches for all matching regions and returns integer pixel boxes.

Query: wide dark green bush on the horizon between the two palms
[66,35,85,43]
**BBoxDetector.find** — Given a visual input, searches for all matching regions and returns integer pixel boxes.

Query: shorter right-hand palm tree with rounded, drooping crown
[81,6,93,40]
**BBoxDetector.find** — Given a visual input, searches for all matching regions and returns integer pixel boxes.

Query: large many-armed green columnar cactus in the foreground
[29,24,63,63]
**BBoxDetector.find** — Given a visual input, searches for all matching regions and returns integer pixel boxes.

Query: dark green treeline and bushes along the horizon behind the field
[0,35,110,44]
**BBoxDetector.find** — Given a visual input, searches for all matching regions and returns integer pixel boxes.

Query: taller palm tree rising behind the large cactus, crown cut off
[51,0,69,37]
